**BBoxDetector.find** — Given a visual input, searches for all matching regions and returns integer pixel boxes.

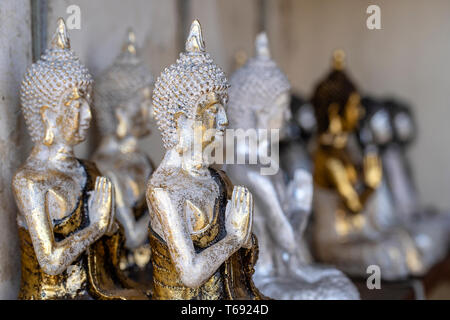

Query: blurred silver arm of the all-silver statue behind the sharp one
[245,171,297,252]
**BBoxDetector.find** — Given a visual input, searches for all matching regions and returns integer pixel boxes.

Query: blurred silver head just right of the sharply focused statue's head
[228,33,290,134]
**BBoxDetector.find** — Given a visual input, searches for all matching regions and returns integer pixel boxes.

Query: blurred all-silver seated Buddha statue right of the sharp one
[226,33,359,299]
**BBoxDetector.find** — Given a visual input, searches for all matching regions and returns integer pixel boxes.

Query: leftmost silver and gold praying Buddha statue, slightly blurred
[12,18,147,300]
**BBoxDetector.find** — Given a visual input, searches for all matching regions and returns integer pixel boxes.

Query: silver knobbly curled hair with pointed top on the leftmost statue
[20,18,93,142]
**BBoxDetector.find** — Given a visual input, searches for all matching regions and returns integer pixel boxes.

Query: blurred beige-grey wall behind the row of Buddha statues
[0,0,450,298]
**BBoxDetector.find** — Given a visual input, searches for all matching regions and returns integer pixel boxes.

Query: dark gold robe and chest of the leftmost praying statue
[18,160,145,299]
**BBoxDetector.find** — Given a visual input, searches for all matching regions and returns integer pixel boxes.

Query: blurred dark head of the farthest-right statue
[386,99,417,145]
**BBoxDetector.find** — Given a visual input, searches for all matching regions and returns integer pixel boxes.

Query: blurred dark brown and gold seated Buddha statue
[311,50,424,280]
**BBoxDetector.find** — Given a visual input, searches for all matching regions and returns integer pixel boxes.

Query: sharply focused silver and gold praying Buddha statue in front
[146,20,263,300]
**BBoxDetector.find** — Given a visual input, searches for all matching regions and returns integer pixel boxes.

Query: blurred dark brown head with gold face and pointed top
[311,50,363,146]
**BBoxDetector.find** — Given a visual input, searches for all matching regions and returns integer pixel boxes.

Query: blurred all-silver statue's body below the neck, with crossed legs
[227,145,359,300]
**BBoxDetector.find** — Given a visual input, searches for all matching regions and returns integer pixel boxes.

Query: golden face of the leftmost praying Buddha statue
[46,88,92,145]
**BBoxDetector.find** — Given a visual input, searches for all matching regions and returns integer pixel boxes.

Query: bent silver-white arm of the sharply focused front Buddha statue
[147,188,242,288]
